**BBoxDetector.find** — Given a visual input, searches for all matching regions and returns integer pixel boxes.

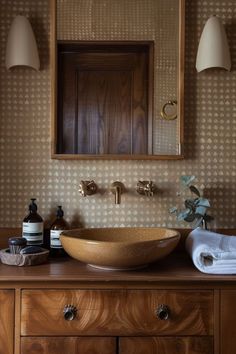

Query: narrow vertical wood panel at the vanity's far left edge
[0,290,14,354]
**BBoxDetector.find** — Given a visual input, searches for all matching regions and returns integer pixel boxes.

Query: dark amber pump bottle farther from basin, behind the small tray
[22,198,43,245]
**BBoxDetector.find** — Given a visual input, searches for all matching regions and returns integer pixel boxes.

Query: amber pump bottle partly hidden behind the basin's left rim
[50,205,69,257]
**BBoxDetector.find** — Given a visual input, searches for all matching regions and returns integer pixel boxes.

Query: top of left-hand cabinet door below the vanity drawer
[21,337,116,354]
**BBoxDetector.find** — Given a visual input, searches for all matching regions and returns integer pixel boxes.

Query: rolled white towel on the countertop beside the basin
[185,227,236,274]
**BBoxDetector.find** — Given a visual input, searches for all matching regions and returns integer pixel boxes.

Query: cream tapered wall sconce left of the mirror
[6,15,40,70]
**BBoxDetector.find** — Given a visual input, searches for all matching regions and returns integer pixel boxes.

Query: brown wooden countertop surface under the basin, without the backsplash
[0,252,236,285]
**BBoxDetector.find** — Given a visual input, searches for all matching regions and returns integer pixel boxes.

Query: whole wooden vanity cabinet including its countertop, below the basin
[0,255,236,354]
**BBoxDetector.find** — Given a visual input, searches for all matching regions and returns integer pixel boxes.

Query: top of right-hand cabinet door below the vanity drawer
[119,337,214,354]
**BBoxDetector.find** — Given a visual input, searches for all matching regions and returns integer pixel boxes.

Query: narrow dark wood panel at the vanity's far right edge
[220,290,236,354]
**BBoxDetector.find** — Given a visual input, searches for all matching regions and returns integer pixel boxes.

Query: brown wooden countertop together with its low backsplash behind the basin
[0,228,236,288]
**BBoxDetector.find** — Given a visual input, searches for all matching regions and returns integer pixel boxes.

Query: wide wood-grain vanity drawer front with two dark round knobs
[21,289,213,336]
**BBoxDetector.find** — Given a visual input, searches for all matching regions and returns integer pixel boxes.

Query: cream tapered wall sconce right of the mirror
[196,16,231,72]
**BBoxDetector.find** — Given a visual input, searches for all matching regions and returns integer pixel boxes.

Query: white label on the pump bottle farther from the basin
[22,222,43,245]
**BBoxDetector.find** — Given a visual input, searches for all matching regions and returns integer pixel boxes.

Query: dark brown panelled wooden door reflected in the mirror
[57,42,149,155]
